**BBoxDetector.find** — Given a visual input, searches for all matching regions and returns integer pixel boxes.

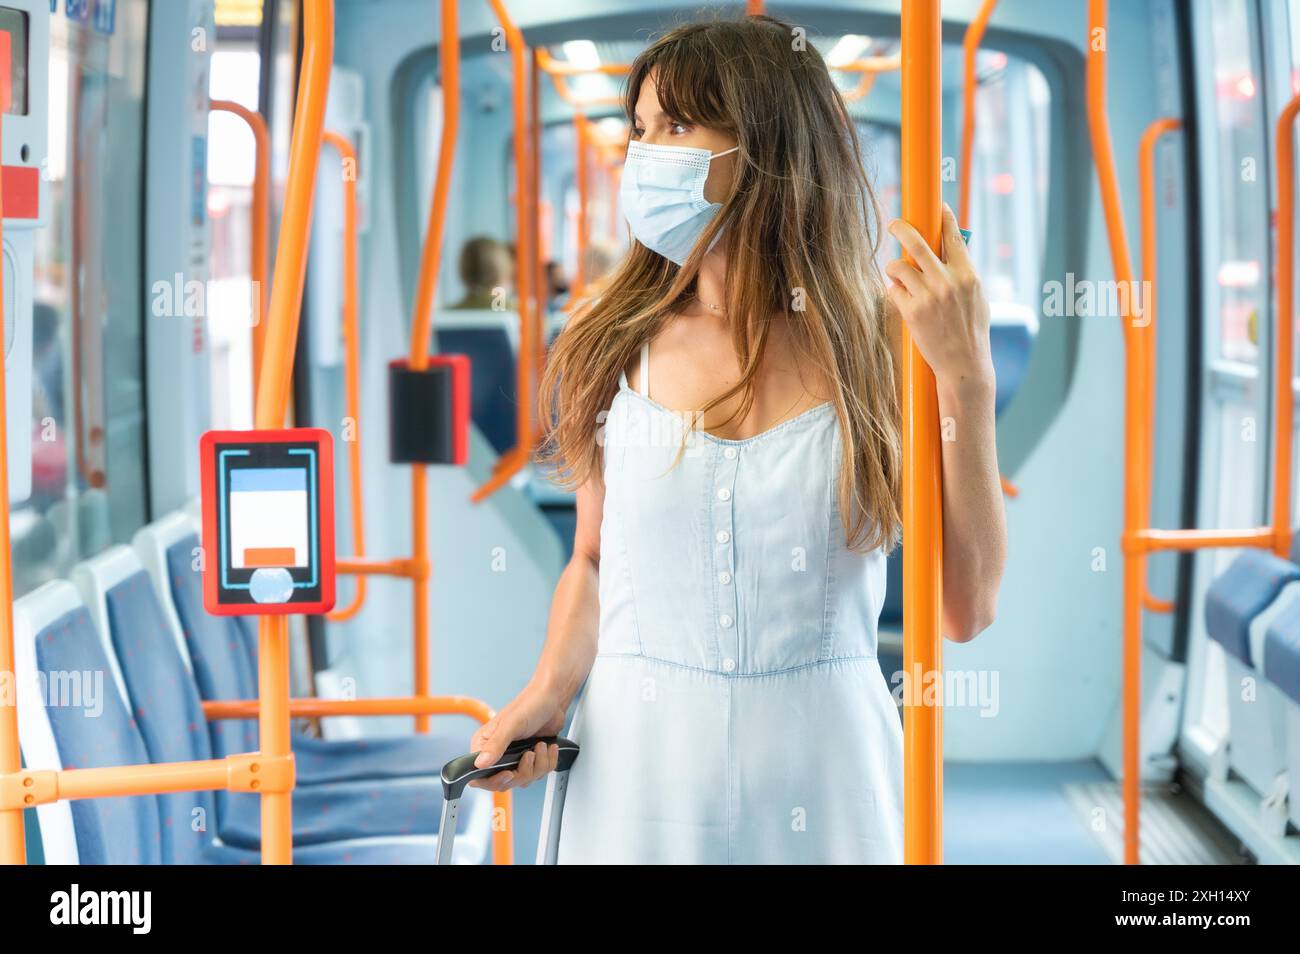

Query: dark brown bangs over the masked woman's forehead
[623,32,736,130]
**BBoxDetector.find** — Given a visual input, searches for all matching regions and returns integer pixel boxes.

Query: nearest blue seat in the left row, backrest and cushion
[14,580,477,864]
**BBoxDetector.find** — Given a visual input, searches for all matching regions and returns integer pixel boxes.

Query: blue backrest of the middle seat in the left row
[73,546,225,864]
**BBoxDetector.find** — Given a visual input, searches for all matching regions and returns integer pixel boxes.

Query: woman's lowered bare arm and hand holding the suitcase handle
[471,480,605,792]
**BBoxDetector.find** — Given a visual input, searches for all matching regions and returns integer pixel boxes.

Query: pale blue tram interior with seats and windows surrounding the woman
[0,0,1300,864]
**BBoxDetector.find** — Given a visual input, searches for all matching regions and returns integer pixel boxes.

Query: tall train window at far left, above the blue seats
[10,9,148,594]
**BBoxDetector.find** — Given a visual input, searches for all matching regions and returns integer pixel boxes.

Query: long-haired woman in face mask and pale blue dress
[473,17,1005,863]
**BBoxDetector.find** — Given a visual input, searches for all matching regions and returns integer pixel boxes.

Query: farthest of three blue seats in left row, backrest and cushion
[134,512,488,785]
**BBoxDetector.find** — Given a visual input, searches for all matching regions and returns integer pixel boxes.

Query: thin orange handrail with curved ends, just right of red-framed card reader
[322,130,365,623]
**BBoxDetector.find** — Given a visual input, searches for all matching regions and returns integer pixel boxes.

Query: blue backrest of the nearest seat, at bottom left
[14,580,163,864]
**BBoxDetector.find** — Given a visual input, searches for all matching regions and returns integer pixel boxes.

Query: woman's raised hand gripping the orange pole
[885,204,996,389]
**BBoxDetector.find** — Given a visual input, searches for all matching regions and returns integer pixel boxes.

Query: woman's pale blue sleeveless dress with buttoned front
[547,348,902,864]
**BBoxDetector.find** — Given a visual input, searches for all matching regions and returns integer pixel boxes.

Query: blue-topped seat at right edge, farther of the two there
[1205,550,1300,797]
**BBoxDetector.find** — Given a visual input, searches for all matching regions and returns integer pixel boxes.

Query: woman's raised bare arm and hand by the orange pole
[885,205,1006,642]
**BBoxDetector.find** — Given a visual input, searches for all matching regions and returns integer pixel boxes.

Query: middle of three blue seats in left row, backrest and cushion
[73,546,491,863]
